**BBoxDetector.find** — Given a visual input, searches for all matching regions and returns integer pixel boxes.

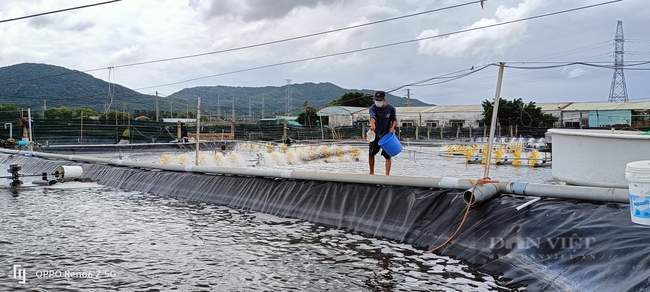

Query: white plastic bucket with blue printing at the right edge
[625,160,650,225]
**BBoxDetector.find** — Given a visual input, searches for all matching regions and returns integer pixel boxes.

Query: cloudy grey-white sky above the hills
[0,0,650,105]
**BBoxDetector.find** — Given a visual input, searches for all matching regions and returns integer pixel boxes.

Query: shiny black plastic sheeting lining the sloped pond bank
[3,157,650,291]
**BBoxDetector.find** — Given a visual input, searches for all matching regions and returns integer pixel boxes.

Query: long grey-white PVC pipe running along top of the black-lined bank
[0,149,629,203]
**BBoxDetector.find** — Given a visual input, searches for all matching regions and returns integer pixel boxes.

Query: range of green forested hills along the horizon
[0,63,427,117]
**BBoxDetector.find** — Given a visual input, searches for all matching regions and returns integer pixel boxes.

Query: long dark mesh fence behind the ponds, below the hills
[0,119,547,145]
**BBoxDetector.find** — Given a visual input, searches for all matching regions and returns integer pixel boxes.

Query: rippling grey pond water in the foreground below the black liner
[0,189,508,291]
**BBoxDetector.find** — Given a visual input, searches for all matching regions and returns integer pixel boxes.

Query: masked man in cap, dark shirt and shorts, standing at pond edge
[368,91,397,175]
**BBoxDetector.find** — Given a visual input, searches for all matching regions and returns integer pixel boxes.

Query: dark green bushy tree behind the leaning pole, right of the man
[482,98,558,127]
